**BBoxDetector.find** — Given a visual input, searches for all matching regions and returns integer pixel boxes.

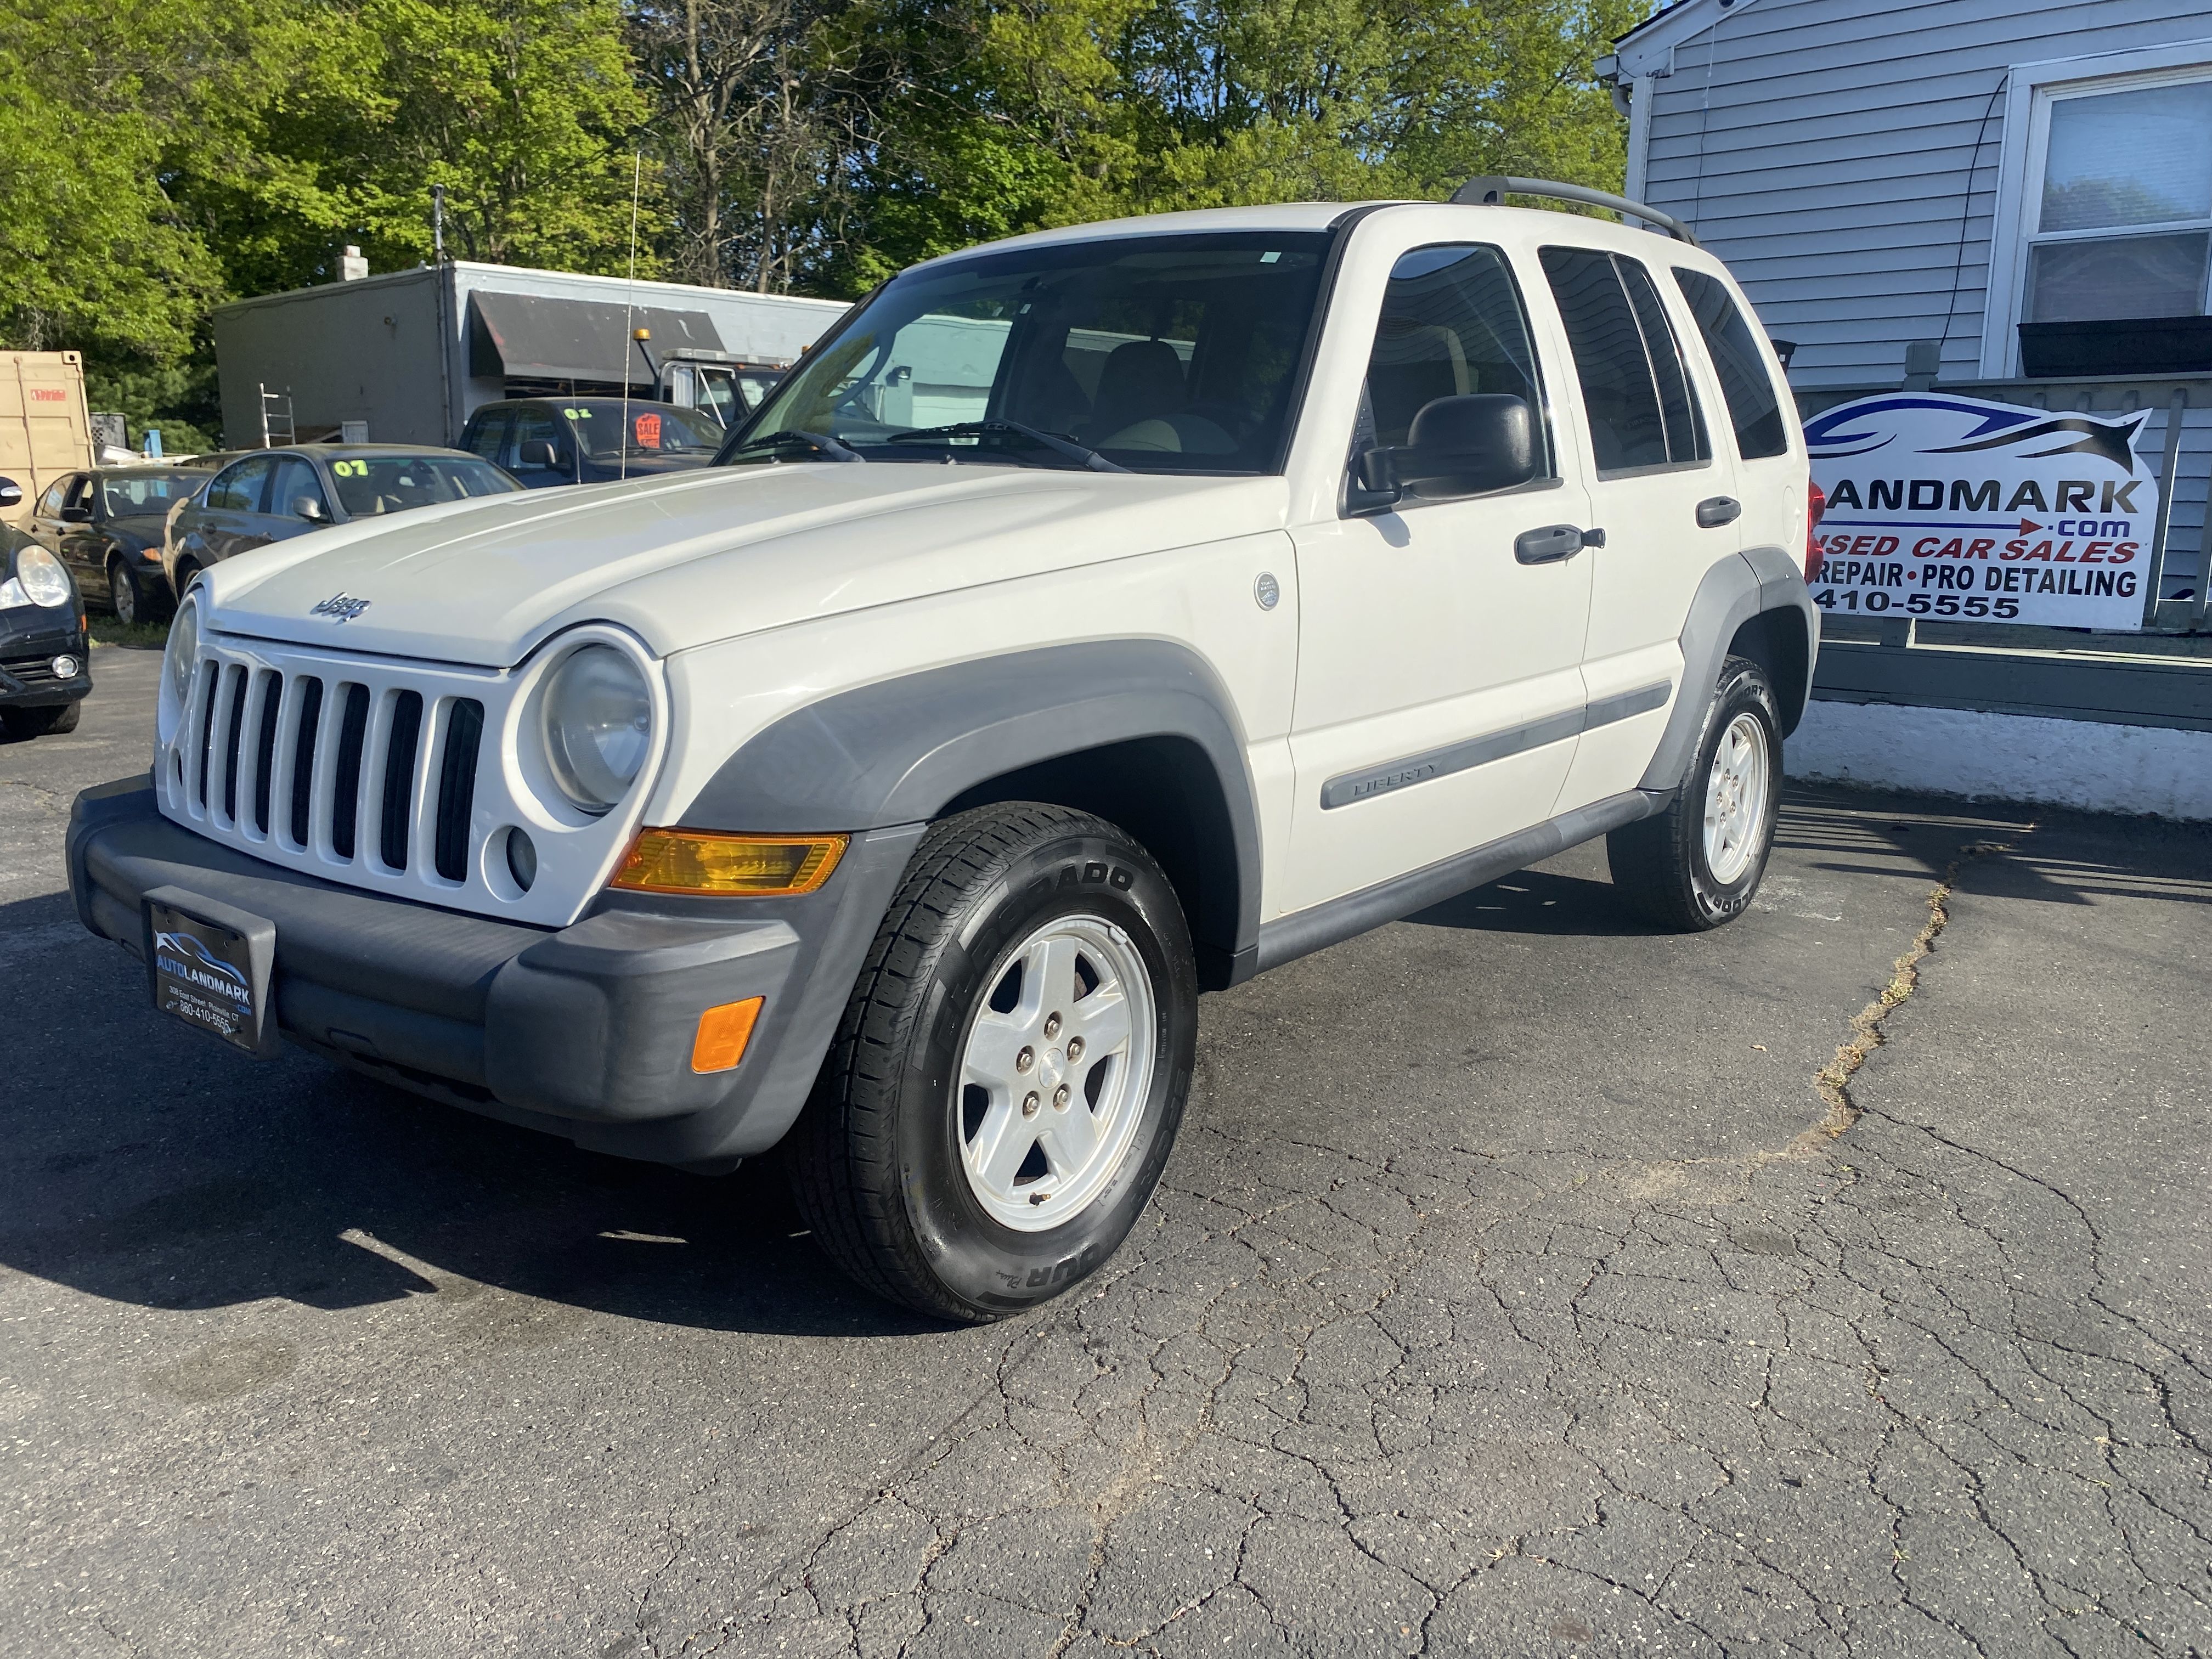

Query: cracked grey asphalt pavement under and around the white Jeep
[0,648,2212,1659]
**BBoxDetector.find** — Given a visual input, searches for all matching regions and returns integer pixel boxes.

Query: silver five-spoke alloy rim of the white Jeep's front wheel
[953,916,1155,1232]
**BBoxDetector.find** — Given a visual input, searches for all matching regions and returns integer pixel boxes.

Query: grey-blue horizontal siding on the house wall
[1621,0,2212,595]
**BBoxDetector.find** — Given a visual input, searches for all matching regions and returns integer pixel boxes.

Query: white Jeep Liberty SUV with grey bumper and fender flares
[69,179,1818,1321]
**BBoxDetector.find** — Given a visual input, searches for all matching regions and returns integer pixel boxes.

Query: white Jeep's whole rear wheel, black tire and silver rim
[1606,657,1783,934]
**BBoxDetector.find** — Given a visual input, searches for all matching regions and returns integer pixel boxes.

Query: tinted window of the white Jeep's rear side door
[1539,248,1712,473]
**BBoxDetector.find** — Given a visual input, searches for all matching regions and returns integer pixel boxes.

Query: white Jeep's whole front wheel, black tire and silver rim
[789,803,1197,1321]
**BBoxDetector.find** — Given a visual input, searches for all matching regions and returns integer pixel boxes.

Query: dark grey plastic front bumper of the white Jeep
[69,778,924,1166]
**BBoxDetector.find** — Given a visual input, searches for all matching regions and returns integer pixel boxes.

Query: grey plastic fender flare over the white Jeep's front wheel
[681,639,1261,969]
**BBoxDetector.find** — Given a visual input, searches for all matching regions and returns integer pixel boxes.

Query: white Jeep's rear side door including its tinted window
[1537,246,1741,812]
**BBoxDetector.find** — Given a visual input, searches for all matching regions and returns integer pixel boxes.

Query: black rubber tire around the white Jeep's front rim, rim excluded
[785,803,1197,1323]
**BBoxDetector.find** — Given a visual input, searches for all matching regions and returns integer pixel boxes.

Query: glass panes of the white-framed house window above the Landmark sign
[2022,80,2212,323]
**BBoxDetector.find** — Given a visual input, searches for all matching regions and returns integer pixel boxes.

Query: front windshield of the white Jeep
[725,230,1329,473]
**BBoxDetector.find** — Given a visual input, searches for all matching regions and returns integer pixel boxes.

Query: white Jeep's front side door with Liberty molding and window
[1278,241,1590,909]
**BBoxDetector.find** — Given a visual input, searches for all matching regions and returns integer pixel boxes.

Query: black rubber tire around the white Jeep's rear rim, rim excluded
[1606,657,1783,934]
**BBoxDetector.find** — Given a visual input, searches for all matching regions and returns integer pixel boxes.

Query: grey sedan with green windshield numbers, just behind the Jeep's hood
[161,444,522,597]
